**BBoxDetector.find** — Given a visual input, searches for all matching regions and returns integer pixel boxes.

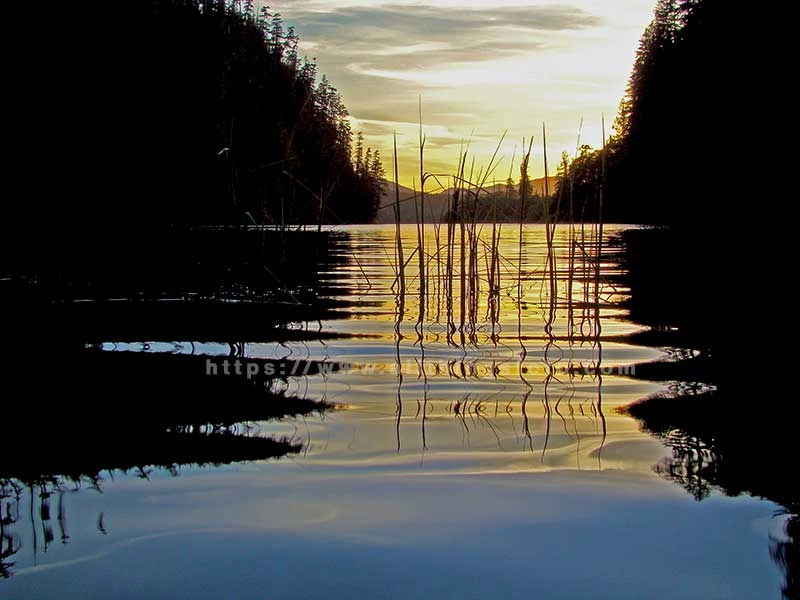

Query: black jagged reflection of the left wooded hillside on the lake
[0,230,348,578]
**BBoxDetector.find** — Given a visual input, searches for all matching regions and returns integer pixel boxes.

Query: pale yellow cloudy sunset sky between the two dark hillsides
[269,0,655,189]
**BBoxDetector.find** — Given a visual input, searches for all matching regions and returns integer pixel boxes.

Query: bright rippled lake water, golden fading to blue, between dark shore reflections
[0,226,797,599]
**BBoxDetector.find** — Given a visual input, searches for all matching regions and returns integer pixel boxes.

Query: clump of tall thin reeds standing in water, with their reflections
[386,119,606,464]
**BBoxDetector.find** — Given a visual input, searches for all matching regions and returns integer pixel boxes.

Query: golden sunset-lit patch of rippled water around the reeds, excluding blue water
[167,224,664,470]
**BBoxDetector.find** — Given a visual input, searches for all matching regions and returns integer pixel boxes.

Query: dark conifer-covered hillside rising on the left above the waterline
[4,0,383,255]
